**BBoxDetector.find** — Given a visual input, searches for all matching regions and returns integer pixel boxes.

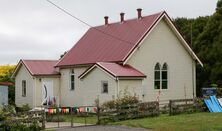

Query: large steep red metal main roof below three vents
[56,12,163,66]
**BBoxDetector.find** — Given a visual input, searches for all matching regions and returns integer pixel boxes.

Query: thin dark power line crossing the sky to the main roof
[46,0,134,45]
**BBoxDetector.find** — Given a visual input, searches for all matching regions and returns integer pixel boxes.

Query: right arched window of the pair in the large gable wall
[161,63,168,89]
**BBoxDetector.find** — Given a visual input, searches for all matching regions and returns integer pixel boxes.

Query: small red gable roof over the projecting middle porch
[79,62,146,79]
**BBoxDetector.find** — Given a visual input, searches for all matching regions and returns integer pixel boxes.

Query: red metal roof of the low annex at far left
[22,60,59,75]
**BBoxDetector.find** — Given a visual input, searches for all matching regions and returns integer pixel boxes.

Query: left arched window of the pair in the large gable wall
[154,63,160,89]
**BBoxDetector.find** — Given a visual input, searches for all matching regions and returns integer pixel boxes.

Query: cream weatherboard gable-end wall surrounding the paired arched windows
[127,20,196,101]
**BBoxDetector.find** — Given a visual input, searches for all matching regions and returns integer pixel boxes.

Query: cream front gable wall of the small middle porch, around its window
[81,68,117,106]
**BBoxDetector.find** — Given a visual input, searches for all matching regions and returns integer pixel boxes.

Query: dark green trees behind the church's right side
[174,0,222,95]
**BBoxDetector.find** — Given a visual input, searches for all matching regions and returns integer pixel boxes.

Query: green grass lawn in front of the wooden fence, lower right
[109,113,222,131]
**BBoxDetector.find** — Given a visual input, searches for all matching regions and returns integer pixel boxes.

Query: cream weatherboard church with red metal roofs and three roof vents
[13,9,203,107]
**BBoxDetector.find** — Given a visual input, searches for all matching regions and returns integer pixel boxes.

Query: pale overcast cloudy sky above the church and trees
[0,0,217,65]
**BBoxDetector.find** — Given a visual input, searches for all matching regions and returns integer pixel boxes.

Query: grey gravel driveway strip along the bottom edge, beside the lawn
[55,126,149,131]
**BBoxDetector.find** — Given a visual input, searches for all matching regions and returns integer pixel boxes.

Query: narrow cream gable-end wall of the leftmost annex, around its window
[15,65,34,107]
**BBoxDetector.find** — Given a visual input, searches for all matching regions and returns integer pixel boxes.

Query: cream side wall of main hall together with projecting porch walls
[60,67,142,106]
